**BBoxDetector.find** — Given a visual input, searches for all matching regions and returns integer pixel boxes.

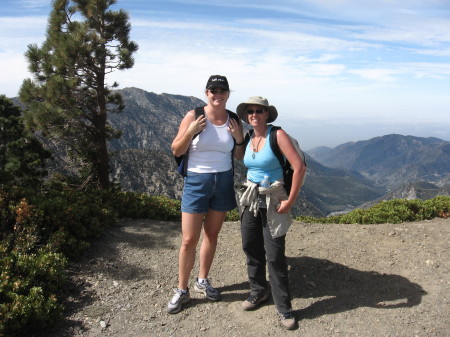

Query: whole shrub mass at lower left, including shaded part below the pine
[0,187,118,336]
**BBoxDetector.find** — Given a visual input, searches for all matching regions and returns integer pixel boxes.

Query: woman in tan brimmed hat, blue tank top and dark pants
[236,96,306,329]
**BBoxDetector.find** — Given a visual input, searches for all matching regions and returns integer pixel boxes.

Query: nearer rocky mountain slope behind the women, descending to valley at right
[105,88,384,216]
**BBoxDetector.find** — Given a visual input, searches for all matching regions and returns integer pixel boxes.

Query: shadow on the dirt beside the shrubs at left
[36,219,180,337]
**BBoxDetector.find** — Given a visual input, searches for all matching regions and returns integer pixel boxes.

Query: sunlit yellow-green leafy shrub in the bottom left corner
[0,199,67,336]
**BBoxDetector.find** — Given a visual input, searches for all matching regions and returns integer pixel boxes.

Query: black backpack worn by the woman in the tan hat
[245,126,307,195]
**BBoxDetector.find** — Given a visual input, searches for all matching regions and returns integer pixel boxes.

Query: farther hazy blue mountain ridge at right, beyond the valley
[308,134,450,191]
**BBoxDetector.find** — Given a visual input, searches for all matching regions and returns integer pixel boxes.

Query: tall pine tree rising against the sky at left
[20,0,138,189]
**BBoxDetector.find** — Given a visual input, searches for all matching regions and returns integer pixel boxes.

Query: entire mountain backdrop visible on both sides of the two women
[15,88,450,216]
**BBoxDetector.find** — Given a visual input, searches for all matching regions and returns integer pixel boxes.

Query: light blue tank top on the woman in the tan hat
[244,125,283,183]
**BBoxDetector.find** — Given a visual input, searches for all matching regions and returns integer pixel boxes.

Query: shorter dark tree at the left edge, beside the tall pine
[0,95,50,191]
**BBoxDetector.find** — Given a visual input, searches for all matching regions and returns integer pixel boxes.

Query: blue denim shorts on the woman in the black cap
[181,170,236,213]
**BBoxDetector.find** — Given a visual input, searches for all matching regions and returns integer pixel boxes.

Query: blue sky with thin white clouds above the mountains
[0,0,450,150]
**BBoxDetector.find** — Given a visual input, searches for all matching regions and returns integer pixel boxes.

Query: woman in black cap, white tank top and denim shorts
[167,75,244,314]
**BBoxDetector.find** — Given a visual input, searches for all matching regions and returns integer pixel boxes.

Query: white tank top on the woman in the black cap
[188,116,234,173]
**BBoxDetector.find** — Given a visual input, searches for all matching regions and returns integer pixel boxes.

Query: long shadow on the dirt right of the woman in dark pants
[288,257,426,318]
